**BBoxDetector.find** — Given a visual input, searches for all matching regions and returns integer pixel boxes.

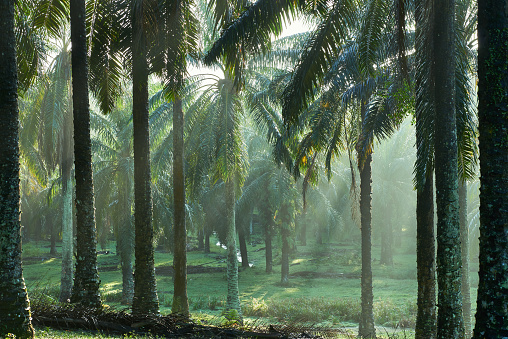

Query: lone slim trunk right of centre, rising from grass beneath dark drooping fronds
[358,103,376,338]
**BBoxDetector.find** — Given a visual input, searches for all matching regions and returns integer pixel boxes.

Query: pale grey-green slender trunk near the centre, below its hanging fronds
[226,179,242,320]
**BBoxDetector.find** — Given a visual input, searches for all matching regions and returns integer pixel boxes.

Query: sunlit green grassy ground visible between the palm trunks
[23,237,477,338]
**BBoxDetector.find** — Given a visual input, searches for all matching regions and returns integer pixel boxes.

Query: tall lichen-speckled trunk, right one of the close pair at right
[432,0,464,339]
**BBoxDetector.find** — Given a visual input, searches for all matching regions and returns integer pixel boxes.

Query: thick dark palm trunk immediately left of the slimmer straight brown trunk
[132,0,159,314]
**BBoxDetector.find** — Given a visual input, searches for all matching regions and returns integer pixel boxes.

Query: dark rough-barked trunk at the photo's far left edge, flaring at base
[0,0,34,338]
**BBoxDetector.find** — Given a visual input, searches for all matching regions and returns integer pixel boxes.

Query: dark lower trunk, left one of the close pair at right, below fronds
[415,172,436,339]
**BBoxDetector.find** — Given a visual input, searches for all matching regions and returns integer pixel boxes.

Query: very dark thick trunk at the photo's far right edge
[474,0,508,339]
